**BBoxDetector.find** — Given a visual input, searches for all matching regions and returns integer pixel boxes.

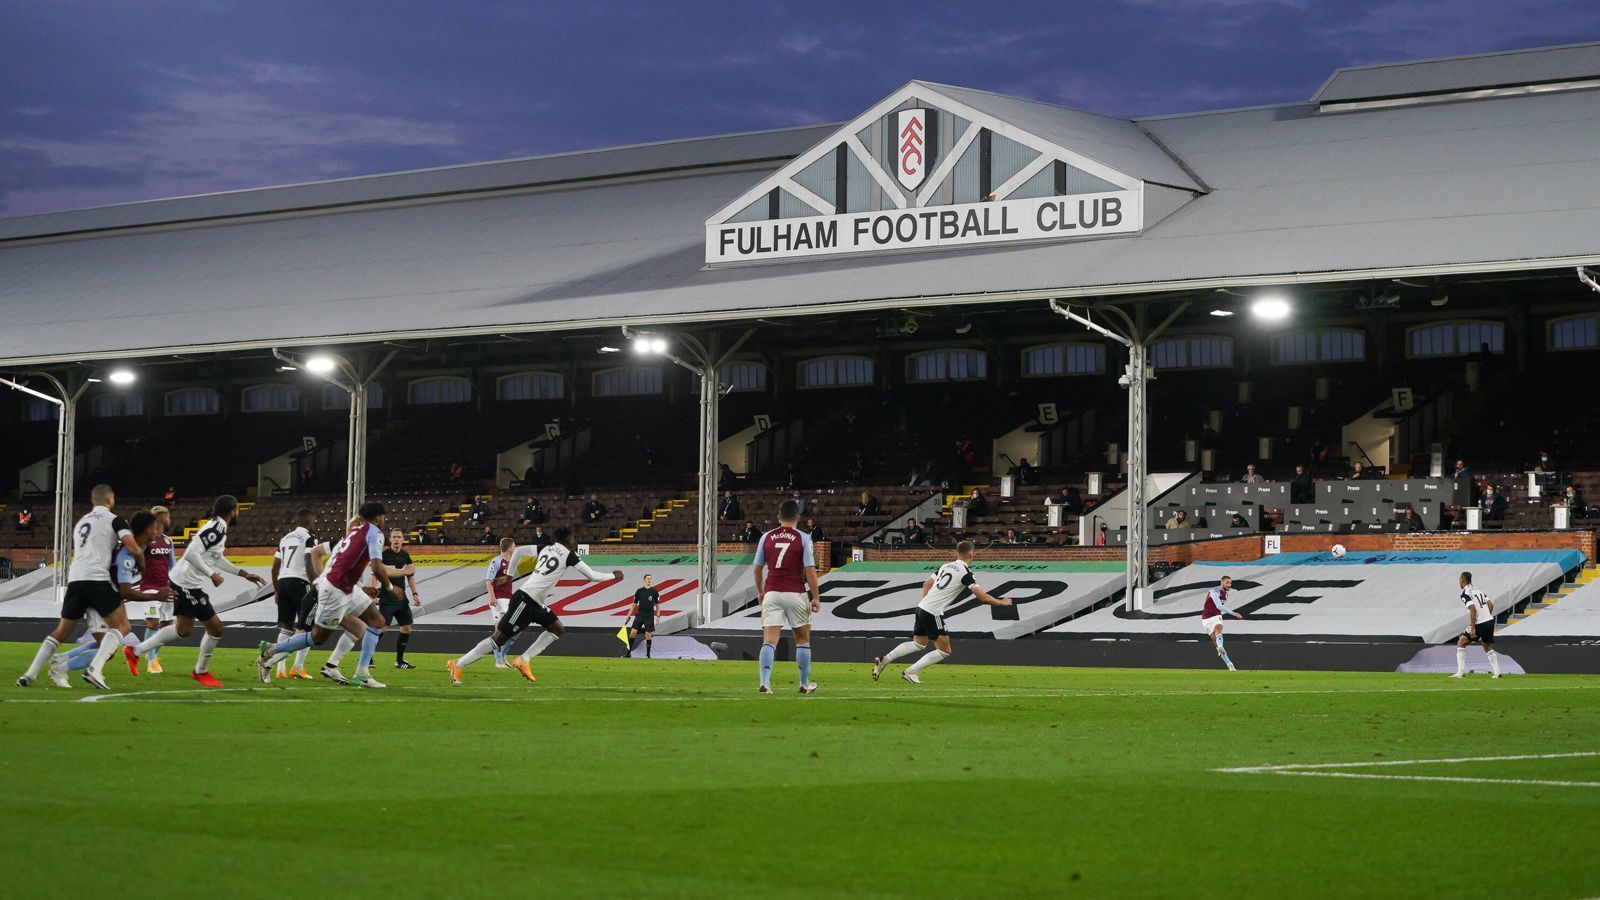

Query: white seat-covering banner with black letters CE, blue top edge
[1046,551,1584,644]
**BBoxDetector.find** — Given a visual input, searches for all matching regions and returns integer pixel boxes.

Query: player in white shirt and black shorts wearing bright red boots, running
[138,493,267,687]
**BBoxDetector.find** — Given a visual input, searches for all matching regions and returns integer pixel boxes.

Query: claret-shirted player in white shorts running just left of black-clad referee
[256,501,392,689]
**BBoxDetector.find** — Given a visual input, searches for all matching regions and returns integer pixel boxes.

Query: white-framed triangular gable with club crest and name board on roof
[706,82,1144,264]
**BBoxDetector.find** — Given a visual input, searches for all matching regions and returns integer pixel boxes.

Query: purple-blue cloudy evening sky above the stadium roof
[9,0,1600,216]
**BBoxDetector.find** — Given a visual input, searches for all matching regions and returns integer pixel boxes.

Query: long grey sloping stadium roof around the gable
[0,48,1600,367]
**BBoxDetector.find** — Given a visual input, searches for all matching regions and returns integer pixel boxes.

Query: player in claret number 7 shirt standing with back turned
[755,500,822,693]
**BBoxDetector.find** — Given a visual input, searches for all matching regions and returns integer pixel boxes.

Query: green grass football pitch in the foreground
[0,644,1600,898]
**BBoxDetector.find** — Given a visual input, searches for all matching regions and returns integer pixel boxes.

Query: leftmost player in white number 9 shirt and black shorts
[16,484,142,690]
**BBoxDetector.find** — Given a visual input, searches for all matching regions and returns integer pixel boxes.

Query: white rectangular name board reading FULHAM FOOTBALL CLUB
[706,189,1144,264]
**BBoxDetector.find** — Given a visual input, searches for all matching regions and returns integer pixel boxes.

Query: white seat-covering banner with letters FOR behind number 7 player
[709,560,1123,639]
